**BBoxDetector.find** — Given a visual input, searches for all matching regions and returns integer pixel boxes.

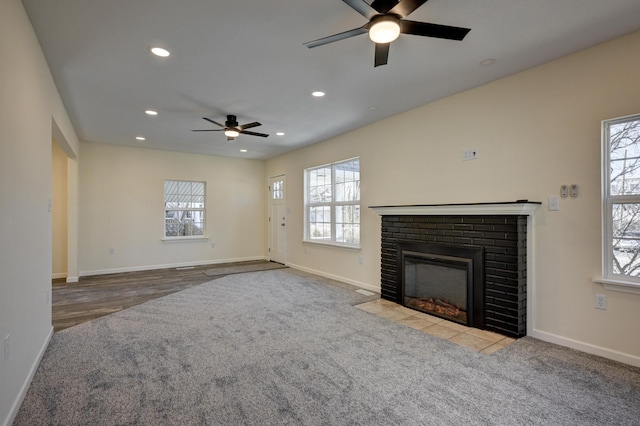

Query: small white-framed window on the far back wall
[164,180,205,238]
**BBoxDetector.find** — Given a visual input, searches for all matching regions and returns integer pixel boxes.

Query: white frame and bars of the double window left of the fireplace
[304,157,362,249]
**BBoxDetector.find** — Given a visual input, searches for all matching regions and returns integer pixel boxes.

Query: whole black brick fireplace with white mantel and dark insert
[371,200,541,337]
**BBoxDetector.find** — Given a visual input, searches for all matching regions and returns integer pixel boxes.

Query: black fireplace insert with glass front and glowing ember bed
[397,243,484,328]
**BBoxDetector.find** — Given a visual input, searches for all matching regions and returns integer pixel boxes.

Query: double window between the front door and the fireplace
[305,158,360,247]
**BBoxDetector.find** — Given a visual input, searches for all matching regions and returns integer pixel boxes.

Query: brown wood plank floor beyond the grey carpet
[52,261,276,332]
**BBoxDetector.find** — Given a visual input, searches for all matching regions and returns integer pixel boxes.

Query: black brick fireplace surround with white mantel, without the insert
[371,201,541,337]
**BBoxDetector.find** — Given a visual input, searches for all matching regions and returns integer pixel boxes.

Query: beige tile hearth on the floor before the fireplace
[355,299,515,355]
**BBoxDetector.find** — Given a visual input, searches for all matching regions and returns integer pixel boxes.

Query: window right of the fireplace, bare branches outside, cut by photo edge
[602,115,640,285]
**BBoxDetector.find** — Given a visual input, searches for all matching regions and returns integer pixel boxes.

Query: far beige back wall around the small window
[79,142,266,275]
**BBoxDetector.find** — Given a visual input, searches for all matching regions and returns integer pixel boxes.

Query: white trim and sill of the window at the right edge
[592,114,640,294]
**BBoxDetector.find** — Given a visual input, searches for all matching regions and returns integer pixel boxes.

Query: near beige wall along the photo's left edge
[0,0,78,424]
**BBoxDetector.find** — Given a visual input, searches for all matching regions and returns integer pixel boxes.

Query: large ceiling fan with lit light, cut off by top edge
[304,0,471,67]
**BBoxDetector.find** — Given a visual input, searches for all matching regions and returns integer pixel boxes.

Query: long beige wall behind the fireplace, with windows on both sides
[266,33,640,365]
